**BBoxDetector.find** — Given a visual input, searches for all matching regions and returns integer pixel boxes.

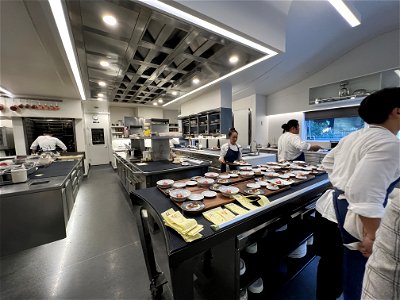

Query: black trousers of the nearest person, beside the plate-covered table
[314,212,343,300]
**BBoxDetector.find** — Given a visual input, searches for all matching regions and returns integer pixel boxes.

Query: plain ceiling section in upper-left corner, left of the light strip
[0,0,80,99]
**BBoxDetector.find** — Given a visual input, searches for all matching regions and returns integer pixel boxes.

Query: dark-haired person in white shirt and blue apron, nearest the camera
[316,88,400,299]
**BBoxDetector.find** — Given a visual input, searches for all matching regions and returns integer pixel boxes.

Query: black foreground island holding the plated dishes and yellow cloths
[131,174,330,299]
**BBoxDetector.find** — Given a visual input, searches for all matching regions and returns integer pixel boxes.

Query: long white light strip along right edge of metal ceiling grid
[134,0,278,56]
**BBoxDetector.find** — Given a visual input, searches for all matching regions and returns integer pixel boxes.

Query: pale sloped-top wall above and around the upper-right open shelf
[266,30,400,115]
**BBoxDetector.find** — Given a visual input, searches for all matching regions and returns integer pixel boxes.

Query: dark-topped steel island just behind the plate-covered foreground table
[114,152,210,193]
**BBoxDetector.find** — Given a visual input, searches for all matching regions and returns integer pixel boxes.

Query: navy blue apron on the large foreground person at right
[333,178,400,300]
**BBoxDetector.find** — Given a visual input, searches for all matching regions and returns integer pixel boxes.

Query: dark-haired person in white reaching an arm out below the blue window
[278,120,321,161]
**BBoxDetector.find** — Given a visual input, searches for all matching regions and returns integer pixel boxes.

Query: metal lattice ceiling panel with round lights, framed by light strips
[66,0,278,105]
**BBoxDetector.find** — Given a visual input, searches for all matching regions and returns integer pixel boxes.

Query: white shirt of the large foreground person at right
[316,125,400,222]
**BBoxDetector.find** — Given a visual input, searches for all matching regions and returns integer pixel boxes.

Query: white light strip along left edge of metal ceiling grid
[48,0,86,100]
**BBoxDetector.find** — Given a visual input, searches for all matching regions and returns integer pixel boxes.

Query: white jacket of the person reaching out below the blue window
[278,132,311,161]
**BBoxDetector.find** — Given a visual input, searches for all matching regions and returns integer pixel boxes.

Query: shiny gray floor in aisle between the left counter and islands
[0,166,324,300]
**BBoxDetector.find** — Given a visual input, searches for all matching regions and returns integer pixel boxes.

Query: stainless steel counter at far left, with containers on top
[0,159,83,256]
